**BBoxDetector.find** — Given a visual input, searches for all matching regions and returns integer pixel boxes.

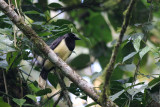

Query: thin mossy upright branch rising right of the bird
[101,0,137,107]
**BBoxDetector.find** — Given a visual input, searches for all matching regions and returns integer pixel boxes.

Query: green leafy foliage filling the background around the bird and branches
[0,0,160,107]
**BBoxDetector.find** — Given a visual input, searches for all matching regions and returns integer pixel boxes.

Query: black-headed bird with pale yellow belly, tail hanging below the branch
[37,33,80,89]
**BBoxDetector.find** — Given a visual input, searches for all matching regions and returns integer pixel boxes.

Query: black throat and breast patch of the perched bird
[65,37,75,51]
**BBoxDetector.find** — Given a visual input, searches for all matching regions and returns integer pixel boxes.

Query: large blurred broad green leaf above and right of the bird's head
[83,11,112,46]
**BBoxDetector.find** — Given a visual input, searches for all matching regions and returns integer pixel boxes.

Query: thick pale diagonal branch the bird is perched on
[0,0,115,105]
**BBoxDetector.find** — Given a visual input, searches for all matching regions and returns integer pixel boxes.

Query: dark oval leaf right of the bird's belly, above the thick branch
[70,54,90,69]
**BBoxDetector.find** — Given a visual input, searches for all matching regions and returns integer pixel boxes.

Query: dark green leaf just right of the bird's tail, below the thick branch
[48,73,59,88]
